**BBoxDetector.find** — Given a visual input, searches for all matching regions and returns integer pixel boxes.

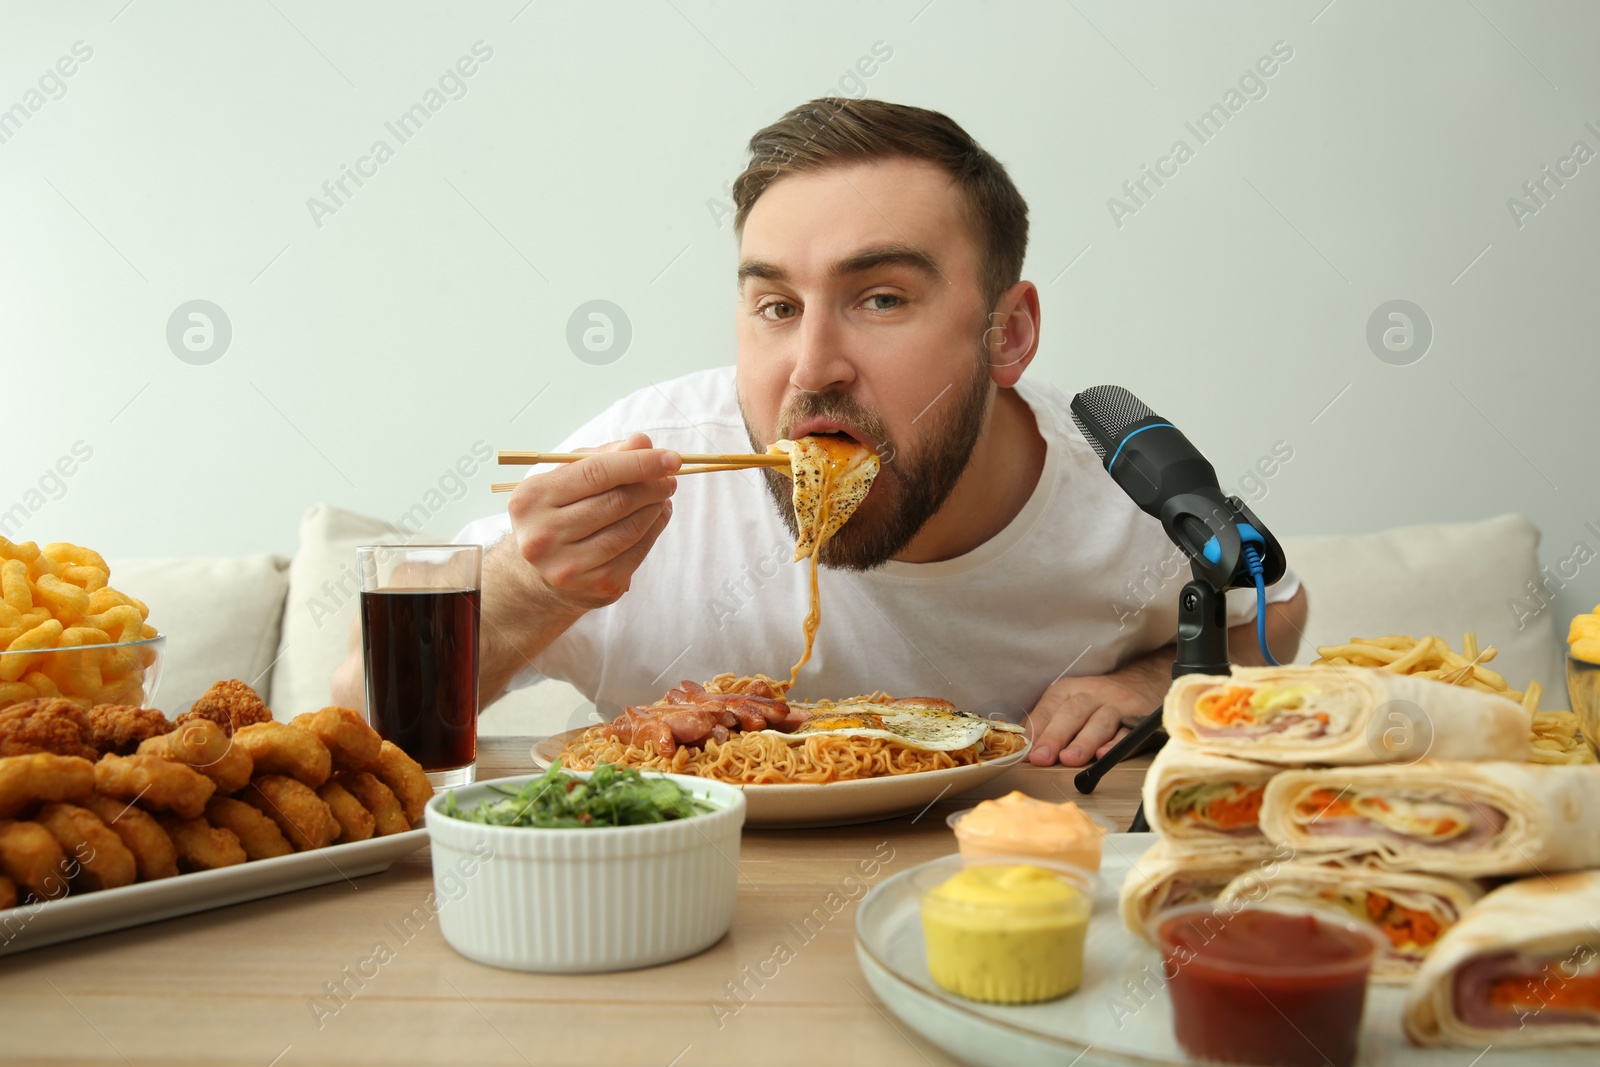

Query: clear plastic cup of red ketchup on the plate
[1152,902,1387,1067]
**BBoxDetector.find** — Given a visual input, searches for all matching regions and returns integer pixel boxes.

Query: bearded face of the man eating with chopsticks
[736,160,994,569]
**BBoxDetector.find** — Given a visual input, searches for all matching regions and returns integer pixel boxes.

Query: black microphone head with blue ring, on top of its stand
[1072,386,1285,589]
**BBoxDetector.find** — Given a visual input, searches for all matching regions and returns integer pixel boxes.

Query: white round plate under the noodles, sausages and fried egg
[533,728,1027,829]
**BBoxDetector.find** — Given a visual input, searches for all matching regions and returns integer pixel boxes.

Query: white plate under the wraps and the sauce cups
[856,833,1595,1067]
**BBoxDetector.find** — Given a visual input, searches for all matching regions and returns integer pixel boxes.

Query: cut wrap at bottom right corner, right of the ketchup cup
[1402,870,1600,1048]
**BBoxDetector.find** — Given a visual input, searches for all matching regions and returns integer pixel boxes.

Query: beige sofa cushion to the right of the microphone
[1283,515,1566,707]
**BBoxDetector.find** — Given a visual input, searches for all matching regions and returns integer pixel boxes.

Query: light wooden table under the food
[0,737,1149,1067]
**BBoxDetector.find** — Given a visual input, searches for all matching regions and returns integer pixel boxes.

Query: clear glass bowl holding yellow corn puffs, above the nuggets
[0,633,166,709]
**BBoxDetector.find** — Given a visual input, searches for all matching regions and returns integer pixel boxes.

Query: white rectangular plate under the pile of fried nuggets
[0,830,427,957]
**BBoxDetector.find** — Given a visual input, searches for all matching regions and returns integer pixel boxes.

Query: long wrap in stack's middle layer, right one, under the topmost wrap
[1261,760,1600,878]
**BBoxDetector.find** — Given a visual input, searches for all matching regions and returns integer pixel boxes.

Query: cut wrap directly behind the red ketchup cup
[1218,862,1483,982]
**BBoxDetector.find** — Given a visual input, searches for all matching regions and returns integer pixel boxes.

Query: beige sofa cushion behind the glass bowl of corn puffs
[109,553,290,715]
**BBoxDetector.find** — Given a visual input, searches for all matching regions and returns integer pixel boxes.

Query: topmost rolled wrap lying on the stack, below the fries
[1162,665,1531,766]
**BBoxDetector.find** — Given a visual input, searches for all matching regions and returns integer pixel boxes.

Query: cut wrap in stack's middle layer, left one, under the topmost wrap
[1144,741,1282,854]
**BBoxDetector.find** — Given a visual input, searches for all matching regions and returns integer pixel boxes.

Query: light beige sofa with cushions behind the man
[109,504,1565,736]
